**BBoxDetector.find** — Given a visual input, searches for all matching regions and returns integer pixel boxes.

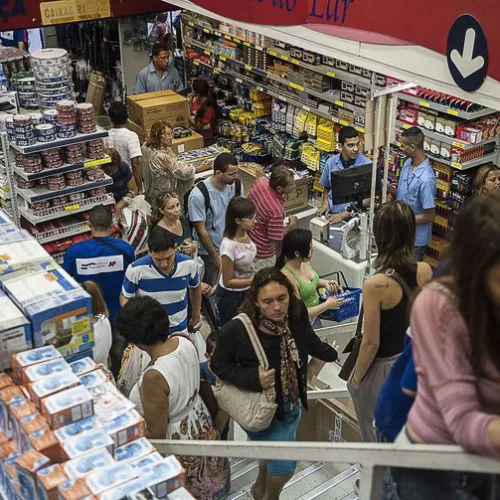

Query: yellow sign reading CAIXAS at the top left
[40,0,111,25]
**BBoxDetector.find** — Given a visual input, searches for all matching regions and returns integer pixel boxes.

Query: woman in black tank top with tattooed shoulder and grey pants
[347,201,432,442]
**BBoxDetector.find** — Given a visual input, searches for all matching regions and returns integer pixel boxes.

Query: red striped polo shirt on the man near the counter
[248,177,285,259]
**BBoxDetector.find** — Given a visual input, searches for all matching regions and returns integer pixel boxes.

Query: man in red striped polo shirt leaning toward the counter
[248,165,297,271]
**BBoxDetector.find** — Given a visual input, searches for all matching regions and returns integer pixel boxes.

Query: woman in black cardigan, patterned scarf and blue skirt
[211,268,338,500]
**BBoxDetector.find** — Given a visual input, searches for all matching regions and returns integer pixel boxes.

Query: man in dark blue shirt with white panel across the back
[63,205,135,323]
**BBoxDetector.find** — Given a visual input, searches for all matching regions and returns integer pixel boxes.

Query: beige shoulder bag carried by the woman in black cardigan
[214,313,278,432]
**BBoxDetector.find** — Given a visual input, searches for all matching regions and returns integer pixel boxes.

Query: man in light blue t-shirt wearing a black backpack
[188,153,244,286]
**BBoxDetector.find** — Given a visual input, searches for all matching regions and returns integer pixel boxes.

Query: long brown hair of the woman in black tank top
[373,201,417,272]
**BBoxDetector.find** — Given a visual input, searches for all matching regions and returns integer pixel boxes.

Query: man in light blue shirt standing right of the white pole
[396,127,436,261]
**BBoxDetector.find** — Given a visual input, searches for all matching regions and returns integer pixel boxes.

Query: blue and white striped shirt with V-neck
[122,253,200,333]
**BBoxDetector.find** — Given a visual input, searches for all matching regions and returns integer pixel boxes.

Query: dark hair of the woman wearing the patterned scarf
[238,267,300,325]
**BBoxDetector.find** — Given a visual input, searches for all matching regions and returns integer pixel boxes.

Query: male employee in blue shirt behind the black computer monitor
[318,127,372,224]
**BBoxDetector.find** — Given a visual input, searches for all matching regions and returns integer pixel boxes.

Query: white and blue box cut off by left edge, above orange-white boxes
[0,290,33,370]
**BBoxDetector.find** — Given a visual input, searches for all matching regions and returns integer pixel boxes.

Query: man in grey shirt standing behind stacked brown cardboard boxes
[134,42,184,94]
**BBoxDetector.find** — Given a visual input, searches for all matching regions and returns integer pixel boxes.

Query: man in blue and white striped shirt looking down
[120,226,204,336]
